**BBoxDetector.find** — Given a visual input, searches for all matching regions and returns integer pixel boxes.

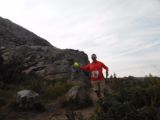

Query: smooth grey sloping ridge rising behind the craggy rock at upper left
[0,17,51,48]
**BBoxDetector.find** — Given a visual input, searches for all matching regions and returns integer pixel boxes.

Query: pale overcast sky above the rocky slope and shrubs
[0,0,160,76]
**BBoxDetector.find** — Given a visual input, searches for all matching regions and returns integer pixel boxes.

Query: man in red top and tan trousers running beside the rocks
[80,54,108,98]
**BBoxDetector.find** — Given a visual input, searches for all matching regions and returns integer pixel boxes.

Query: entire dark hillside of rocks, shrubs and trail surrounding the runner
[0,17,160,120]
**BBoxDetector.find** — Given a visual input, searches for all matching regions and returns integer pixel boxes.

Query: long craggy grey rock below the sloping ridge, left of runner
[0,46,88,80]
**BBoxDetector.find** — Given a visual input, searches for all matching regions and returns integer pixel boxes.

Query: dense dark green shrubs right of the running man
[90,76,160,120]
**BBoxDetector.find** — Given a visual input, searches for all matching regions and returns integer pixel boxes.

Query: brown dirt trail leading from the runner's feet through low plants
[37,93,98,120]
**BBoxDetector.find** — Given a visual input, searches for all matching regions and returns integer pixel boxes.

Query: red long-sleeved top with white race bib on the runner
[80,61,108,81]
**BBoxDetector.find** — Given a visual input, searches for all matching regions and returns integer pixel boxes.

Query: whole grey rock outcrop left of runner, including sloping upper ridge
[0,17,88,80]
